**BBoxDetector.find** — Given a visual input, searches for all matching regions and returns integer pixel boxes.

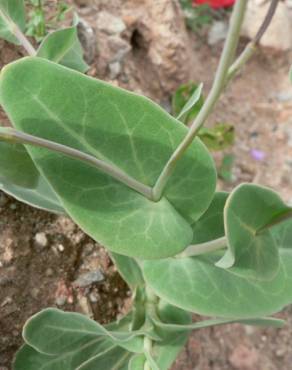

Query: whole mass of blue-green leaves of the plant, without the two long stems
[0,0,292,370]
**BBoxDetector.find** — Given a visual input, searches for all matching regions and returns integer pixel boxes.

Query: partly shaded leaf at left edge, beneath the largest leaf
[0,142,65,213]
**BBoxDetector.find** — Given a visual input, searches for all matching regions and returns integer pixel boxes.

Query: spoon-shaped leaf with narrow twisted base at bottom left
[23,308,142,355]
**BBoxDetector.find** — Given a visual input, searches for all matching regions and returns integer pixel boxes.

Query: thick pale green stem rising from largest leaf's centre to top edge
[153,0,247,201]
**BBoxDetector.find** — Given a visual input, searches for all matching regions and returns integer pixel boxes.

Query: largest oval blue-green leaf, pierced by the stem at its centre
[0,58,216,259]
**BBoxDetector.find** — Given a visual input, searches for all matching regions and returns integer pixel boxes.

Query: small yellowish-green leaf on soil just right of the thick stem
[198,123,234,151]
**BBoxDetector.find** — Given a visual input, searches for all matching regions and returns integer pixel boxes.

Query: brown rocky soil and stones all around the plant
[0,0,292,370]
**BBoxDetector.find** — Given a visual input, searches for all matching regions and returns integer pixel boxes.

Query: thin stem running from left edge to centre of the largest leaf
[0,127,152,200]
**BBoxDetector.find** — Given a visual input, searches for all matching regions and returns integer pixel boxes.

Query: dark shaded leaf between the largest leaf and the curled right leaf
[192,192,228,244]
